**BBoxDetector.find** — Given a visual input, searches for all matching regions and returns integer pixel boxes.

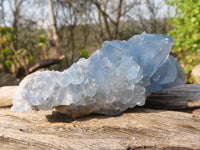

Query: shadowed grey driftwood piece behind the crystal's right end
[145,84,200,110]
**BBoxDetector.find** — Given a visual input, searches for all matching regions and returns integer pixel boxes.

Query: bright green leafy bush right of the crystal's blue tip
[168,0,200,83]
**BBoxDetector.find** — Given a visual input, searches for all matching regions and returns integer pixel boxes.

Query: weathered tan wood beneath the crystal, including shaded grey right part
[0,85,200,150]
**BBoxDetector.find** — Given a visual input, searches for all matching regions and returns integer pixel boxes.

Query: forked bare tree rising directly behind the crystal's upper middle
[92,0,138,40]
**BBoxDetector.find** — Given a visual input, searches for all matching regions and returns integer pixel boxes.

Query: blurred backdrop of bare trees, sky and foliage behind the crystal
[0,0,200,86]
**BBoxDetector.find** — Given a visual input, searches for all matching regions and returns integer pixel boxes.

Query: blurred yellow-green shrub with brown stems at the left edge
[0,27,33,73]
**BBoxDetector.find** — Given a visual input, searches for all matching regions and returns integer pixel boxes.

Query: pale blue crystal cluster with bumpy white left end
[12,33,185,117]
